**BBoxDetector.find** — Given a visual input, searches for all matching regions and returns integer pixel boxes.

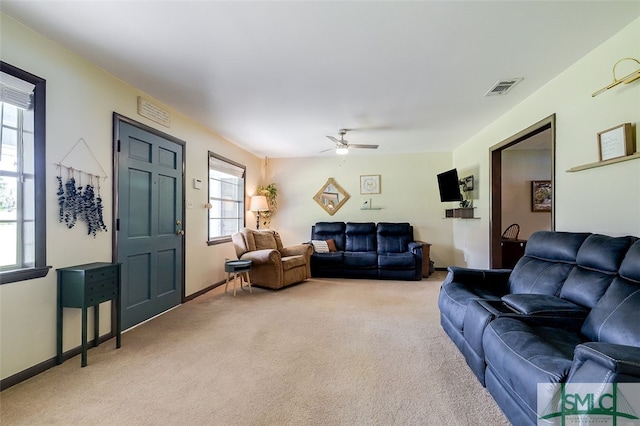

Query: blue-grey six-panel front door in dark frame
[115,116,184,329]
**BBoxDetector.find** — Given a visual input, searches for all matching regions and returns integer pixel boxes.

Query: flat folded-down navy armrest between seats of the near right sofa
[502,294,589,318]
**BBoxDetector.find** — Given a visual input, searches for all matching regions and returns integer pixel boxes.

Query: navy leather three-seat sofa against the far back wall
[311,222,422,281]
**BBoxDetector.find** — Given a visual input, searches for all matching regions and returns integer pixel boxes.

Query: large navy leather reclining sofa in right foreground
[438,231,640,425]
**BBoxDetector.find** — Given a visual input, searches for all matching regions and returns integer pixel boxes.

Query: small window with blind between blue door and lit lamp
[209,152,246,244]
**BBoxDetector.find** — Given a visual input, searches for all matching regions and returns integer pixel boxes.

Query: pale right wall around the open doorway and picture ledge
[453,18,640,267]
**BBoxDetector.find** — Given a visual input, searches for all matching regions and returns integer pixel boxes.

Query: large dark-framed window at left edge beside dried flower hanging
[0,62,49,284]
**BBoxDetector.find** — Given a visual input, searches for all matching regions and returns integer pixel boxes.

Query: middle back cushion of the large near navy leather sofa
[560,234,635,308]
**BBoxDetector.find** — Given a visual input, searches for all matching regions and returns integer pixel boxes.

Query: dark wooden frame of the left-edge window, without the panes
[0,61,51,284]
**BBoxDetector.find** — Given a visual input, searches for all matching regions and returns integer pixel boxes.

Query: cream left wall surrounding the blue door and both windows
[0,15,261,379]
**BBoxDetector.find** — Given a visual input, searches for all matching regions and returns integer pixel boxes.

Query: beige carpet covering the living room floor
[0,272,508,426]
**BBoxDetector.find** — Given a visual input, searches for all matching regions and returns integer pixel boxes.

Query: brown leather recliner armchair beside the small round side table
[231,228,313,289]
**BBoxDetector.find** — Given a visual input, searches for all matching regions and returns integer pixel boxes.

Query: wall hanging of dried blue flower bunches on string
[56,138,107,238]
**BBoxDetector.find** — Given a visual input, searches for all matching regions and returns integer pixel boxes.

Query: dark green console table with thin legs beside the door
[56,262,122,367]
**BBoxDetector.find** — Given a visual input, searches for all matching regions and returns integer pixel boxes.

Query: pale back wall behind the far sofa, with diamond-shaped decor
[269,153,453,266]
